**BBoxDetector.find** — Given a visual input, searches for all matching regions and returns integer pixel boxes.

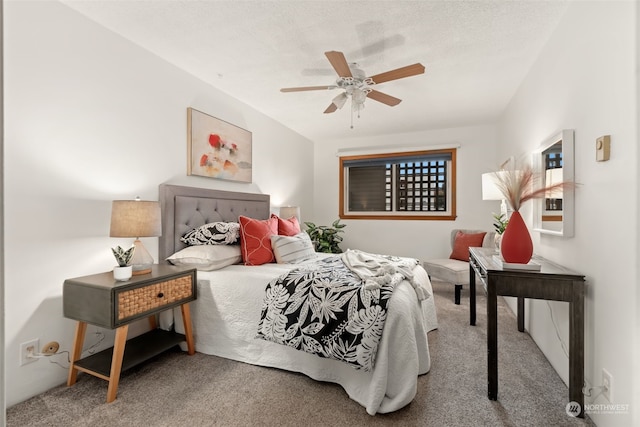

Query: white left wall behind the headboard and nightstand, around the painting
[4,1,313,406]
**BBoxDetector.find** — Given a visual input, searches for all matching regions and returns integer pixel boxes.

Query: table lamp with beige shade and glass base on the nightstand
[109,197,162,276]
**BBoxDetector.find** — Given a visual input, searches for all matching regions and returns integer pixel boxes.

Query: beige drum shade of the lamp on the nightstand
[109,200,162,238]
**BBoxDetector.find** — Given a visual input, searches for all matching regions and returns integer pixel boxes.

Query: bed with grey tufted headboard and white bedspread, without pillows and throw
[159,184,437,415]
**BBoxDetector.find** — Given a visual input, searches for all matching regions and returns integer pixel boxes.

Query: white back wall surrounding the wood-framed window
[312,124,501,260]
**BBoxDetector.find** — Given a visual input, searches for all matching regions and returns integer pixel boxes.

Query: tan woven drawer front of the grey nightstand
[118,276,193,320]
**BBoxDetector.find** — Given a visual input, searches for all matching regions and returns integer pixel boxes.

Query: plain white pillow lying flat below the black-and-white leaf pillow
[167,245,242,271]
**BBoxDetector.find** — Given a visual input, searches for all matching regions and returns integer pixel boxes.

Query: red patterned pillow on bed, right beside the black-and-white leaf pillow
[238,215,278,265]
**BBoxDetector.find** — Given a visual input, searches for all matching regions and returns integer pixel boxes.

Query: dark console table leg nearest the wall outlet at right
[569,282,584,418]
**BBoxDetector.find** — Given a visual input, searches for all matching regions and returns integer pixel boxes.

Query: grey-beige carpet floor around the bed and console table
[7,281,593,427]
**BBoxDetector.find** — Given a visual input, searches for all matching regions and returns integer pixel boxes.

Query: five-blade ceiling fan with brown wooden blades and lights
[280,51,424,128]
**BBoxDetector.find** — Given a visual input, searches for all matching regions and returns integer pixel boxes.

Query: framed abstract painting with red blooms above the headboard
[187,108,252,182]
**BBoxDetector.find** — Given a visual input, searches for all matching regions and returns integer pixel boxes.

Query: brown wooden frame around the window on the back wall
[338,148,457,221]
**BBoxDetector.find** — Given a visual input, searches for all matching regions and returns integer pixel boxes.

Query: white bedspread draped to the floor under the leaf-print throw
[174,254,438,415]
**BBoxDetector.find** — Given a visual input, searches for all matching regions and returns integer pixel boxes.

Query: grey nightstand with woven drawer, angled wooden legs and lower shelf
[62,265,197,403]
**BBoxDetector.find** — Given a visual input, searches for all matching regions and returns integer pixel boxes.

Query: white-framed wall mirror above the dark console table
[533,129,574,237]
